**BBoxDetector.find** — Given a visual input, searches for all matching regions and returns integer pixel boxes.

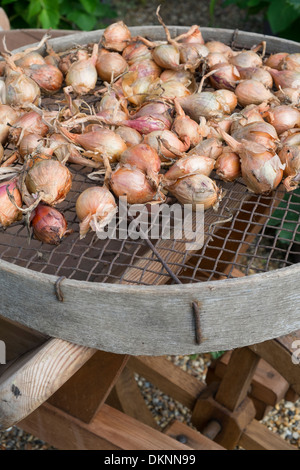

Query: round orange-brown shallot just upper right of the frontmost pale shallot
[110,166,157,204]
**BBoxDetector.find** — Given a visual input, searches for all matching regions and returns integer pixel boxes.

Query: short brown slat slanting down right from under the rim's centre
[128,357,205,409]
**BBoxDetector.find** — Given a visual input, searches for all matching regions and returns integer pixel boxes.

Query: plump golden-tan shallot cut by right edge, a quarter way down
[265,105,300,135]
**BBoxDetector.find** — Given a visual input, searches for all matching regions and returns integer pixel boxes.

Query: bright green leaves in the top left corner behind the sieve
[0,0,116,31]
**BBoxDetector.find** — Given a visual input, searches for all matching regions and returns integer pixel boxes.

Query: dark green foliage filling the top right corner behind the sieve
[217,0,300,41]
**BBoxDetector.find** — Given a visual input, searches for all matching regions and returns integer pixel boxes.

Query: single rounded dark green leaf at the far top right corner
[267,0,297,34]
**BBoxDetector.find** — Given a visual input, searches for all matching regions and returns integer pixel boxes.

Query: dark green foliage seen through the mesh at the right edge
[268,189,300,244]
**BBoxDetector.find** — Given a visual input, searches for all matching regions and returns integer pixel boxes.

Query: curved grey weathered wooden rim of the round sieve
[0,26,300,356]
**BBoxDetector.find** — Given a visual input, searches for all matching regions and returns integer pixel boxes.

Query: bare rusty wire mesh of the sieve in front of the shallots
[0,34,300,285]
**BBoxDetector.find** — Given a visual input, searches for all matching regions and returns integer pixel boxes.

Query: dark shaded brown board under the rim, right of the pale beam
[48,351,128,423]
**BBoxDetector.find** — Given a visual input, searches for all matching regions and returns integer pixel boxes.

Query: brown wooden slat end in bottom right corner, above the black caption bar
[239,420,297,450]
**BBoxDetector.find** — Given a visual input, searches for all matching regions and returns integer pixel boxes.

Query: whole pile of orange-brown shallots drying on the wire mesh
[0,9,300,244]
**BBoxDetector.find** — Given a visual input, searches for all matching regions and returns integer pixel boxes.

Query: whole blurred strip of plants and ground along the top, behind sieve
[0,0,300,41]
